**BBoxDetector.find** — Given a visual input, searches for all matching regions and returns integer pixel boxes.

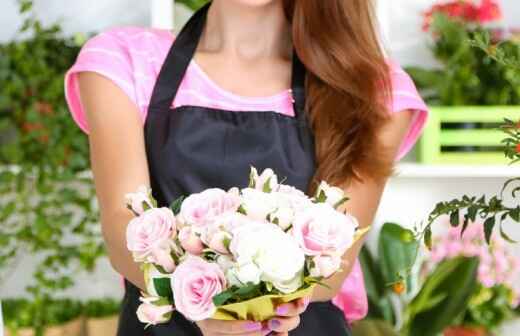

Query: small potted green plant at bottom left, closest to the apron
[84,298,121,336]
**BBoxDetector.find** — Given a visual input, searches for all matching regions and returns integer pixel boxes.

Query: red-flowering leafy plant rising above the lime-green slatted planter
[406,0,520,106]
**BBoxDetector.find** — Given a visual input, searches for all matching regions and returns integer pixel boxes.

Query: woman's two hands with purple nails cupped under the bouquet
[197,298,310,336]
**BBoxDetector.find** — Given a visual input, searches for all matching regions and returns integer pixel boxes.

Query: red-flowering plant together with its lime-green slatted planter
[406,0,520,164]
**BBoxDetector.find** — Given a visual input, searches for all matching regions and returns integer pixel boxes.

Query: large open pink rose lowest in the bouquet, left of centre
[171,256,226,321]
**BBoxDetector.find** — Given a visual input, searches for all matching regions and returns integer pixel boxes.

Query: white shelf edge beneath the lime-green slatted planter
[395,163,520,178]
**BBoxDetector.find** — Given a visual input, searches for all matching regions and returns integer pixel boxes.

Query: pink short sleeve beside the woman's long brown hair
[389,61,429,161]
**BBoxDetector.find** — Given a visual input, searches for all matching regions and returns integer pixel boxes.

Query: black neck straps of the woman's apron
[150,2,305,119]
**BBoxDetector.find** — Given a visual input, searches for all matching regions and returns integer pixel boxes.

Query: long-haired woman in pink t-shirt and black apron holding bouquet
[65,0,427,336]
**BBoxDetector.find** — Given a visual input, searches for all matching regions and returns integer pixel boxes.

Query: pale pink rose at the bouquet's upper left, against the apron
[180,188,240,228]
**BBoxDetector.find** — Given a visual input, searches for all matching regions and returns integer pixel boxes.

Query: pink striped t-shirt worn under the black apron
[65,26,428,321]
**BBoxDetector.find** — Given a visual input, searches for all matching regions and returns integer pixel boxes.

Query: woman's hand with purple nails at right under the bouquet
[265,297,310,336]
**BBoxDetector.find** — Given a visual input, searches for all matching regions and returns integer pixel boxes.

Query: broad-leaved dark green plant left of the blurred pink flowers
[353,223,479,336]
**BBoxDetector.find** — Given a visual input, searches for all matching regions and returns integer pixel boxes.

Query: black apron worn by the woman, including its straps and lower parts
[118,4,349,336]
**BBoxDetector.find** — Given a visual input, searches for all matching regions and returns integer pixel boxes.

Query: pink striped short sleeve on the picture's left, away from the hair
[65,28,144,134]
